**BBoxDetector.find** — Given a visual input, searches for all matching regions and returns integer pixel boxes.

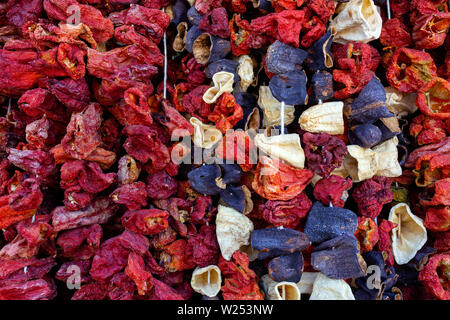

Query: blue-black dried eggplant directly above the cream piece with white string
[269,70,308,105]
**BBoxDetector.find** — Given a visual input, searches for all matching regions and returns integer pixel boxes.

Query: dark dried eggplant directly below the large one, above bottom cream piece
[311,235,366,279]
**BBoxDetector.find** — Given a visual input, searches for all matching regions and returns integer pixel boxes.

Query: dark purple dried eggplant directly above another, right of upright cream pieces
[266,40,308,74]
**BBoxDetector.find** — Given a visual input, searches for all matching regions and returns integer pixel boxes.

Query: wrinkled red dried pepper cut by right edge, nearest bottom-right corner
[419,253,450,300]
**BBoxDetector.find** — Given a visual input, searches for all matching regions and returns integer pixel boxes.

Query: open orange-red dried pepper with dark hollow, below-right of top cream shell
[386,48,437,93]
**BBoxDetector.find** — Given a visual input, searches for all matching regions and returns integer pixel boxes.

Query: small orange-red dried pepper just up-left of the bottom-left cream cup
[160,239,195,272]
